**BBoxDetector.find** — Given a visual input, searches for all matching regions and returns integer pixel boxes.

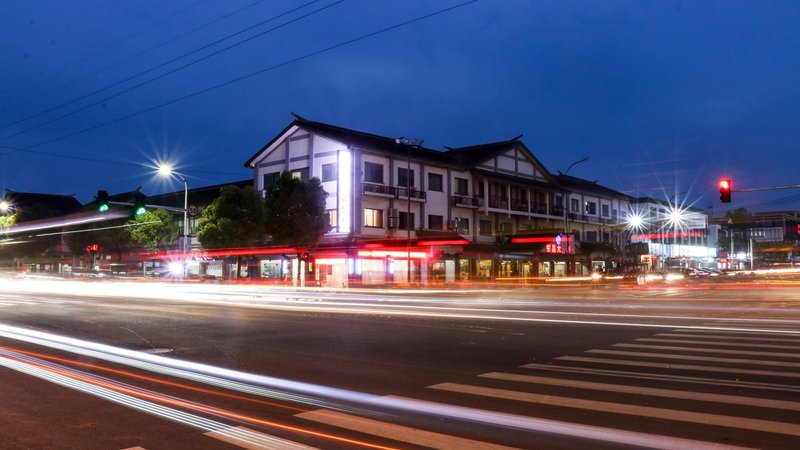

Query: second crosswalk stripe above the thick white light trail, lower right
[479,372,800,411]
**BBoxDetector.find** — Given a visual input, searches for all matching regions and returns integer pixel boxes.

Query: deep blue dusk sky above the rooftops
[0,0,800,215]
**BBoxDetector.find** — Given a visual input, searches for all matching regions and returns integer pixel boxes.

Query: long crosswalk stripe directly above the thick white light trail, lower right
[429,383,800,436]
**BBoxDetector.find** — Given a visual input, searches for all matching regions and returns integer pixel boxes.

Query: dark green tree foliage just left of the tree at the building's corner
[197,186,265,248]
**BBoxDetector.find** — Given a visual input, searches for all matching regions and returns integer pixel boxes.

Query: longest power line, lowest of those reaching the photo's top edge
[0,0,479,160]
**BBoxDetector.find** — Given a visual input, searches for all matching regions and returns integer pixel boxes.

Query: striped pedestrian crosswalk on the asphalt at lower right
[296,319,800,449]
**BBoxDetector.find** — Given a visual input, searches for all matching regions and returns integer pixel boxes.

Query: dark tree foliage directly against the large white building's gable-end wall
[264,172,330,247]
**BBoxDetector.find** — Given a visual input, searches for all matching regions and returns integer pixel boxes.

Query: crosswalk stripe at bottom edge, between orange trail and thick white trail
[295,409,513,450]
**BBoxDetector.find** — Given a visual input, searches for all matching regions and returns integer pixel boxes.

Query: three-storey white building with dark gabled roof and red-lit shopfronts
[245,114,628,285]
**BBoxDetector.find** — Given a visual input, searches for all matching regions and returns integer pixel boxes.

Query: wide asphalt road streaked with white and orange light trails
[0,280,800,450]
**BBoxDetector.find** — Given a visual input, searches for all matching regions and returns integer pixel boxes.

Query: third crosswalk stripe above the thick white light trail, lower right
[520,363,800,392]
